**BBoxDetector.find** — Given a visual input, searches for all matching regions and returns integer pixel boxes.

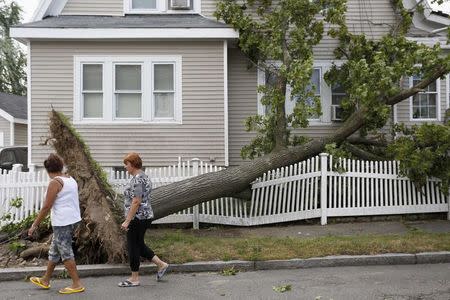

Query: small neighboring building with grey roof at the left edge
[0,93,28,148]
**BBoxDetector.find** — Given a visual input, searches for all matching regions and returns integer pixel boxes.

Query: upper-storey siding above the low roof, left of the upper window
[61,0,124,16]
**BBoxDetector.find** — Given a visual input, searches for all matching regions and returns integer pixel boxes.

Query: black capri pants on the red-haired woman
[127,218,155,272]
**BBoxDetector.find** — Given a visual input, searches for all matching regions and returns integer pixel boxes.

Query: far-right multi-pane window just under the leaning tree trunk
[410,76,439,120]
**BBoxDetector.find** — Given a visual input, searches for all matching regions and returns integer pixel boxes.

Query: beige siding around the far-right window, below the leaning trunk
[397,79,447,126]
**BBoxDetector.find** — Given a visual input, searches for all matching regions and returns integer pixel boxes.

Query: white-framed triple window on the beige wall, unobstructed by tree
[74,56,182,124]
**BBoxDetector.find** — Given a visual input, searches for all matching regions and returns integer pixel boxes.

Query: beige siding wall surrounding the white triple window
[31,41,225,166]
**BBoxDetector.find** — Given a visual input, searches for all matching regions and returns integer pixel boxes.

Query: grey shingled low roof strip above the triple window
[13,14,231,28]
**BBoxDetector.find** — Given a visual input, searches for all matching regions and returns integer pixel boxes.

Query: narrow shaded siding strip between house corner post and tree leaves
[228,48,258,166]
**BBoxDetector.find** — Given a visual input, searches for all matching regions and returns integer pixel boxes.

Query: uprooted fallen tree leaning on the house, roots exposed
[19,0,450,263]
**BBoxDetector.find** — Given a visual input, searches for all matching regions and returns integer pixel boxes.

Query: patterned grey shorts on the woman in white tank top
[48,222,79,263]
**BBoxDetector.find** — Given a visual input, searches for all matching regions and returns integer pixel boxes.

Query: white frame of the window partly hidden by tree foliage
[257,61,334,126]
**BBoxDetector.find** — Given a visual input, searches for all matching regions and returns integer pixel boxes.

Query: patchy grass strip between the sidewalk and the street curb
[146,230,450,263]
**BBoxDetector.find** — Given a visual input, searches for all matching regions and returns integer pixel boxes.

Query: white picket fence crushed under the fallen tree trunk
[0,154,450,228]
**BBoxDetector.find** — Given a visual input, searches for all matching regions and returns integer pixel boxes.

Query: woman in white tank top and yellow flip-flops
[28,154,84,294]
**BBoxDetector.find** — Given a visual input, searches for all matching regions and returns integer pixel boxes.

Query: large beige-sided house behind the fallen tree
[11,0,449,167]
